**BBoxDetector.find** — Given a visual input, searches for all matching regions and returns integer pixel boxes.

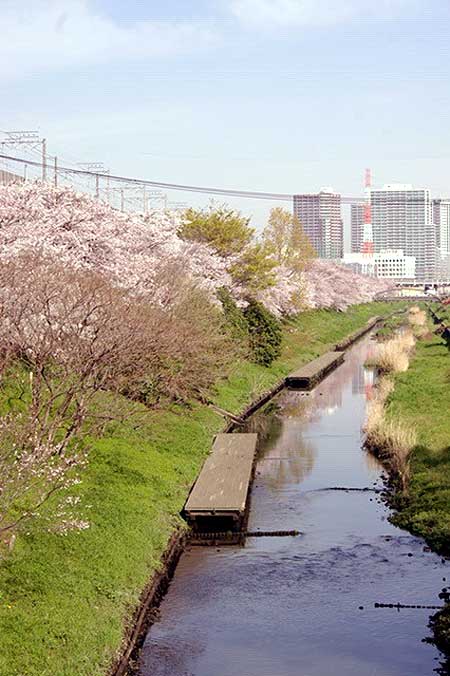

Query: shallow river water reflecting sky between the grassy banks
[139,338,448,676]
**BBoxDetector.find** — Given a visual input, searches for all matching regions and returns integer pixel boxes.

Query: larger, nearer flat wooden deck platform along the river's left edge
[184,433,258,532]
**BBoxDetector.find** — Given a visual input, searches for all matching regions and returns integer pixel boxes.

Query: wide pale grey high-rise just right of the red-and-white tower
[371,184,437,282]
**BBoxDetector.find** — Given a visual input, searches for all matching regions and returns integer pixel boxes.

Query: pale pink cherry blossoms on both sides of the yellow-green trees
[0,182,389,316]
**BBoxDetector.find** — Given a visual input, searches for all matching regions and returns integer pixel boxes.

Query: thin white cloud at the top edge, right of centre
[229,0,415,29]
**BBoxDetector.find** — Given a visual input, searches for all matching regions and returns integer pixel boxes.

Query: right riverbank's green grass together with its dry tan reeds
[366,308,450,673]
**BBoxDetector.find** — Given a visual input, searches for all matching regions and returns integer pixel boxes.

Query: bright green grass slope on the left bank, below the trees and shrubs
[0,303,404,676]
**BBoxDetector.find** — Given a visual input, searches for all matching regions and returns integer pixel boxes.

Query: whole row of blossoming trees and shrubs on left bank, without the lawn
[0,183,390,544]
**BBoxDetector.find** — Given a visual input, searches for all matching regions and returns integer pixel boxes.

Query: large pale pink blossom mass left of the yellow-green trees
[0,182,231,302]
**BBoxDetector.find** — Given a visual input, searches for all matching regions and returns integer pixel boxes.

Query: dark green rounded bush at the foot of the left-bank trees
[243,299,282,366]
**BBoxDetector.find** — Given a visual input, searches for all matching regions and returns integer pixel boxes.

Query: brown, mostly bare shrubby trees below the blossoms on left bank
[0,253,233,538]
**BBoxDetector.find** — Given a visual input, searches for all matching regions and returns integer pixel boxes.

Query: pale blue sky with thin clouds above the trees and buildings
[0,0,450,243]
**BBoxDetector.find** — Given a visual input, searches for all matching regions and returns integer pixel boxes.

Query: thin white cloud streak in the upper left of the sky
[0,0,219,79]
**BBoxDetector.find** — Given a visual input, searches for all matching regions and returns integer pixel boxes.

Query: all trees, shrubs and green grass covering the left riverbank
[0,183,400,676]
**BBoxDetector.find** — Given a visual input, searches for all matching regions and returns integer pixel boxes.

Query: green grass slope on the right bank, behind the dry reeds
[388,336,450,554]
